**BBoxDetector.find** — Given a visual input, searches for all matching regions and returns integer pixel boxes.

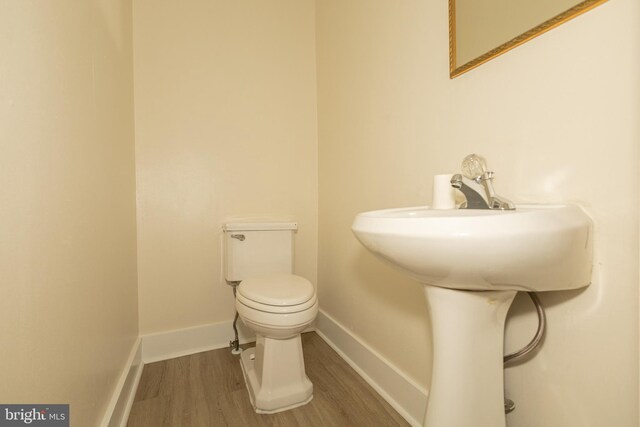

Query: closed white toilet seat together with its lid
[236,274,317,314]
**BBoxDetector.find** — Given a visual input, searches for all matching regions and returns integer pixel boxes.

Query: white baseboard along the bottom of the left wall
[100,338,144,427]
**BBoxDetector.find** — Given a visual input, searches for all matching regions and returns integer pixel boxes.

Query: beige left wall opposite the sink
[0,0,137,426]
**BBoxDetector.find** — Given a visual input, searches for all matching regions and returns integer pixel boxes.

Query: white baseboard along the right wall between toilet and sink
[315,310,428,427]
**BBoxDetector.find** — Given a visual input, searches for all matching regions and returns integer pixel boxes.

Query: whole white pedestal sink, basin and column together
[352,204,593,427]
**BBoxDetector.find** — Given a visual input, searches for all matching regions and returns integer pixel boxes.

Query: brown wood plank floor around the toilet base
[128,332,409,427]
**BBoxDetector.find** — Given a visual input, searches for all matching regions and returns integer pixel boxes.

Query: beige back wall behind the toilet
[134,0,317,333]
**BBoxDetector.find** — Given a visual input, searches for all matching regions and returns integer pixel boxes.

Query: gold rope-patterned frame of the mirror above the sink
[449,0,607,78]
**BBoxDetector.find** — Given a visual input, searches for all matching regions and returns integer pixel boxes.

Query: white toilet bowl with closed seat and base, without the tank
[236,274,318,413]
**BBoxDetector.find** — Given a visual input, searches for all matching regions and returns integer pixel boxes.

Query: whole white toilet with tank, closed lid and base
[223,222,318,414]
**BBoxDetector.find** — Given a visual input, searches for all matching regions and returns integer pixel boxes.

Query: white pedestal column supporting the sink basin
[423,285,517,427]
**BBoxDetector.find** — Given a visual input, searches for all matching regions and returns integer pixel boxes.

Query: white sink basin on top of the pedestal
[352,204,593,292]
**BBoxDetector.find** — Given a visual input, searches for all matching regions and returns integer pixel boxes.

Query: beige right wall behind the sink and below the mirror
[316,0,640,427]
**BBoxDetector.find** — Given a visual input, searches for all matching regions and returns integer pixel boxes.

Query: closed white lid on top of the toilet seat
[238,274,315,307]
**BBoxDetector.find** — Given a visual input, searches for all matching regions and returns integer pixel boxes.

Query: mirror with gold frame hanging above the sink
[449,0,607,78]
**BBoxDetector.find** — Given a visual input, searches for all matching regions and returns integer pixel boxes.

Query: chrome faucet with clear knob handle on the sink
[451,154,516,210]
